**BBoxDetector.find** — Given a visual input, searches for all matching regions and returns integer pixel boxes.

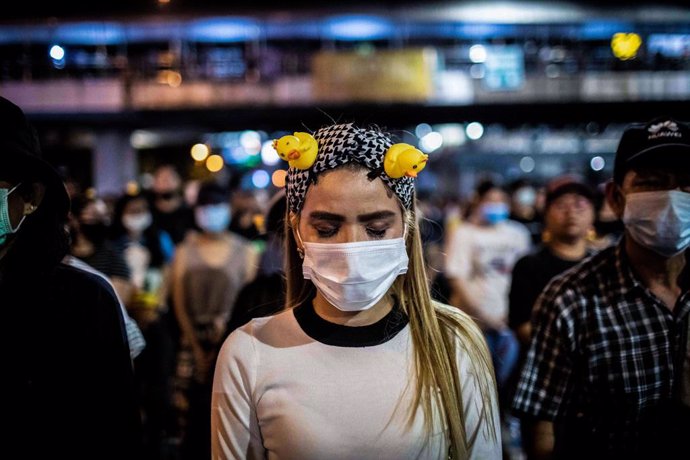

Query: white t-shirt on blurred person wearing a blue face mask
[446,220,532,323]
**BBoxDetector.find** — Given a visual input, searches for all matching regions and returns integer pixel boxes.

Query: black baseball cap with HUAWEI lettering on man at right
[613,117,690,184]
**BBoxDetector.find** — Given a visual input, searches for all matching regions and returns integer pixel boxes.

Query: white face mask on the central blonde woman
[302,238,408,311]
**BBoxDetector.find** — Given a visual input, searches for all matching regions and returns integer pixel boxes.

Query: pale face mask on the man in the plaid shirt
[623,190,690,257]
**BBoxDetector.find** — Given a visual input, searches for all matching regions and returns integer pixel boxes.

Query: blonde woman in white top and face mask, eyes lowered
[211,124,501,459]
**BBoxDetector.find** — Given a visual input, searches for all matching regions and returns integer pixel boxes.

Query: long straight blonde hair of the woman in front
[285,168,498,459]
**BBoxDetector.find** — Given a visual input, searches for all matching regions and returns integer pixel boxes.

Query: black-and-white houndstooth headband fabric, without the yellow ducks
[286,123,414,214]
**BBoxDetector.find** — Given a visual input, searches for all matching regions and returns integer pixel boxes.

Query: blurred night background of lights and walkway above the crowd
[0,0,690,198]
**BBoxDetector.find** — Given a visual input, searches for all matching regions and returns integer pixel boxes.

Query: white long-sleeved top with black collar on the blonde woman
[211,304,501,460]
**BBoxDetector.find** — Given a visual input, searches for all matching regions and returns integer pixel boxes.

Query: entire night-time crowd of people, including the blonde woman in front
[0,94,690,460]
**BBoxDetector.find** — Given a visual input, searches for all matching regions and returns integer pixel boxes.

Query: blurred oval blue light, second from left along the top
[186,17,261,43]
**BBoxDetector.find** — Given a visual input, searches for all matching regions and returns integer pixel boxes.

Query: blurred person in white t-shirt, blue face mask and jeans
[445,179,532,424]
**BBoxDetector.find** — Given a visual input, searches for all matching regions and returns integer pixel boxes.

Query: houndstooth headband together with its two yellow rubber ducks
[273,123,428,213]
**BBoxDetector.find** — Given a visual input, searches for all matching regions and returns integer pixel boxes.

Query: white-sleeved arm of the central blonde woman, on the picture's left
[211,328,266,460]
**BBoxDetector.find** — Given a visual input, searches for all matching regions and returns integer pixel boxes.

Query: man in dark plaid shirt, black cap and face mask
[513,117,690,459]
